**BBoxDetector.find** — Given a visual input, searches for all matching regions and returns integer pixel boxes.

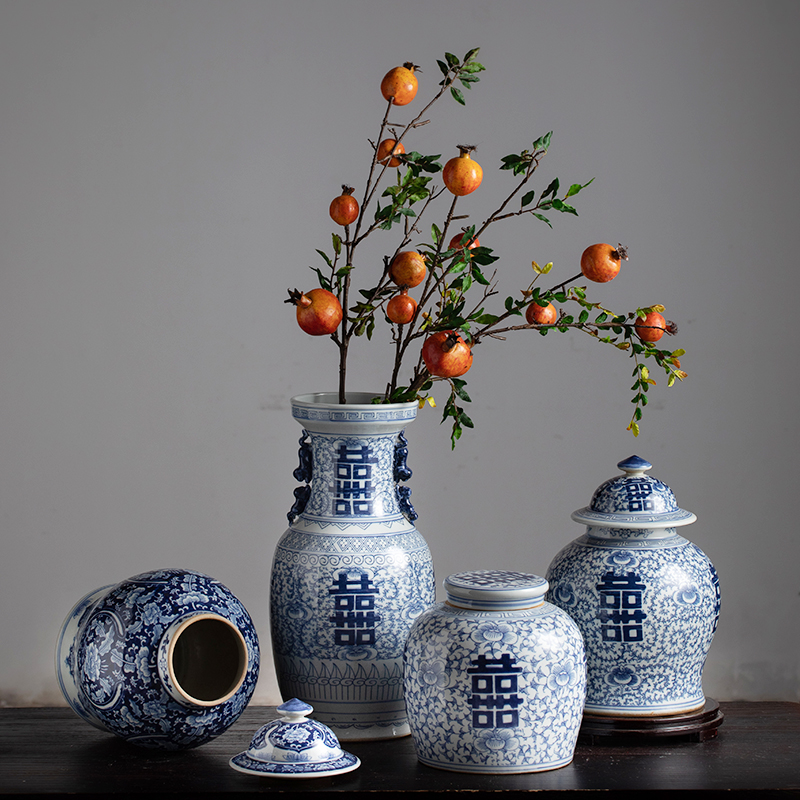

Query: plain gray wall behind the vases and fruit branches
[0,0,800,705]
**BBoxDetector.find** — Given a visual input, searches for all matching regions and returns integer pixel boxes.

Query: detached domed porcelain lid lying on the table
[230,697,361,778]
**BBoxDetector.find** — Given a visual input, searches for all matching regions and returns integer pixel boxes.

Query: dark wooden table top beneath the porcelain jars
[0,703,800,797]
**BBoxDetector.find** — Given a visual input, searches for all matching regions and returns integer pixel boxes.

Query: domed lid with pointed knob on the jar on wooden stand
[572,456,697,528]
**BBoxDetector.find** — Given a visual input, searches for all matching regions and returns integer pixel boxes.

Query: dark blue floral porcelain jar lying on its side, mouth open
[56,569,259,750]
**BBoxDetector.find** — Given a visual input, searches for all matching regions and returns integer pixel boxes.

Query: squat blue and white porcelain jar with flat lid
[404,570,586,774]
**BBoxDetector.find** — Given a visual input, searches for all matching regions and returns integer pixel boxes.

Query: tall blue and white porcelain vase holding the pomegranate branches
[270,393,435,741]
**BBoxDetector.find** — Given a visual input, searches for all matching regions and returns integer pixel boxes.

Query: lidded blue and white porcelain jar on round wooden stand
[547,456,720,717]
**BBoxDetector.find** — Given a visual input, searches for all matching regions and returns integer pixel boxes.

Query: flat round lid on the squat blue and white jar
[444,569,549,611]
